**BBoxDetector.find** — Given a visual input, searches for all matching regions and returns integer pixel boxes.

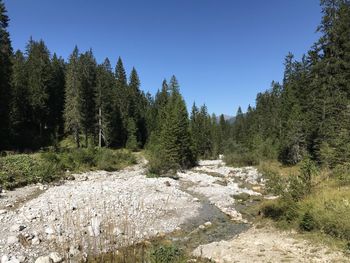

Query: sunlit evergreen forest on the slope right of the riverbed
[230,0,350,167]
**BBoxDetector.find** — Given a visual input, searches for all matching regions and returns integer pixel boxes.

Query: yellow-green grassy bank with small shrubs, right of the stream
[258,163,350,252]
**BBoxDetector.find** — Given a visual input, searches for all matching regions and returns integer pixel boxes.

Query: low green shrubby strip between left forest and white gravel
[0,148,136,189]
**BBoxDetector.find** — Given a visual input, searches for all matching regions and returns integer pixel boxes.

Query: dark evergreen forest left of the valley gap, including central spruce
[0,0,232,175]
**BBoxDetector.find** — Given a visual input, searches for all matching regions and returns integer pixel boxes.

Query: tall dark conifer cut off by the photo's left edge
[0,0,12,150]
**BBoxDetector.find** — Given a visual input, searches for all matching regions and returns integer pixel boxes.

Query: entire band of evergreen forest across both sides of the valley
[0,0,350,173]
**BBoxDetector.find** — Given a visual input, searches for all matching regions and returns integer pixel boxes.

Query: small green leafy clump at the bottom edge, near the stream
[150,244,185,263]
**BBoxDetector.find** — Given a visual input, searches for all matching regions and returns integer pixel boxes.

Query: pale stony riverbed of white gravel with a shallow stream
[0,160,346,263]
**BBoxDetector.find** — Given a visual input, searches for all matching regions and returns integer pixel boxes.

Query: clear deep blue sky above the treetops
[4,0,321,115]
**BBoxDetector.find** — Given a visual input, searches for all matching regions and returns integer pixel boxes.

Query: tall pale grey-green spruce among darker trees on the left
[64,46,82,147]
